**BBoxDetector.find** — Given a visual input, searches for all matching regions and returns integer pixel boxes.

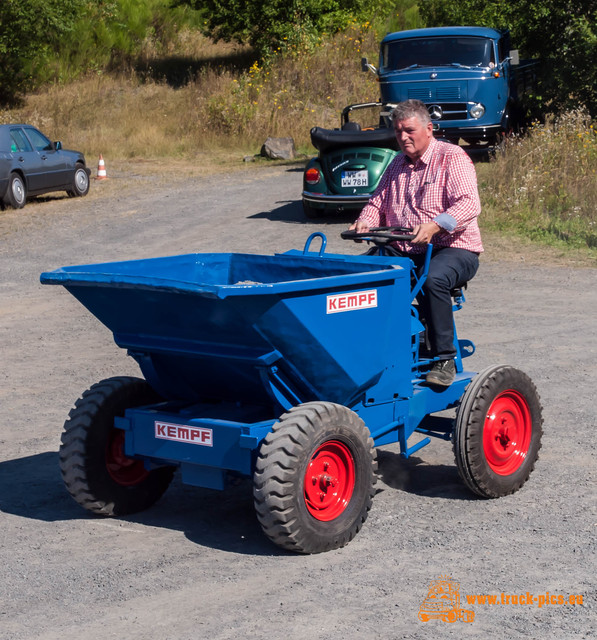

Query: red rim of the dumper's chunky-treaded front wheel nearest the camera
[305,440,355,522]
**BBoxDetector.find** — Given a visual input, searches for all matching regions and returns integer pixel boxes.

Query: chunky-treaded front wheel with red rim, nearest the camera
[253,402,377,553]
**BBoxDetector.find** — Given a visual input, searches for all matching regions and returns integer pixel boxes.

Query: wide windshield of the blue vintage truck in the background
[380,37,495,73]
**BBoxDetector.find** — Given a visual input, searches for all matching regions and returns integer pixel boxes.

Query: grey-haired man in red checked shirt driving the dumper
[350,100,483,387]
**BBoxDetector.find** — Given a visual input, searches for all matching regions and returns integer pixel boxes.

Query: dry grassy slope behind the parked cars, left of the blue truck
[0,25,378,159]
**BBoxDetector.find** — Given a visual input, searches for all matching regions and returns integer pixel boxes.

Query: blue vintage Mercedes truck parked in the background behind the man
[362,27,537,144]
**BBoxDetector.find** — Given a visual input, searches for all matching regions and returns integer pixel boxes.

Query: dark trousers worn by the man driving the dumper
[408,247,479,360]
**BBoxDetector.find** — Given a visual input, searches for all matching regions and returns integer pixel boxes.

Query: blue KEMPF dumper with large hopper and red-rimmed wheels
[41,229,542,553]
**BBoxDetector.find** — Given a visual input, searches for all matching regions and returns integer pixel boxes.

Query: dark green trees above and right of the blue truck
[419,0,597,115]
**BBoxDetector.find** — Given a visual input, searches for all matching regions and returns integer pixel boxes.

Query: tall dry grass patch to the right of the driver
[479,111,597,250]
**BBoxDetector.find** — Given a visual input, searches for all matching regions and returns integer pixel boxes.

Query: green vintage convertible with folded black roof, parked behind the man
[303,102,400,218]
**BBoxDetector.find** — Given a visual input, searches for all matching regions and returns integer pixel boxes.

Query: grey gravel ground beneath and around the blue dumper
[0,166,597,640]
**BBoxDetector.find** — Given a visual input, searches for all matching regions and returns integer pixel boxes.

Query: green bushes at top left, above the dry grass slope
[0,0,203,104]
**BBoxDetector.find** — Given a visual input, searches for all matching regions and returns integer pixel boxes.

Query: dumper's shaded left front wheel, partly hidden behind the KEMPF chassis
[59,377,174,516]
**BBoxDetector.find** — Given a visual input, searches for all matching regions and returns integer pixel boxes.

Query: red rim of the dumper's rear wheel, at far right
[483,389,533,476]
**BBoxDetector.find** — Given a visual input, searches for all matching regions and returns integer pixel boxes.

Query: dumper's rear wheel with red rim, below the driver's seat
[453,365,543,498]
